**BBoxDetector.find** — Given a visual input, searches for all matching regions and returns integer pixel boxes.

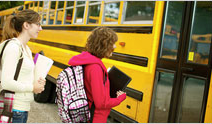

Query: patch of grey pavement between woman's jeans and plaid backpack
[27,101,62,123]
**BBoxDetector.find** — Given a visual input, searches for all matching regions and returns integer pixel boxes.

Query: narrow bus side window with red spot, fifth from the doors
[64,1,74,24]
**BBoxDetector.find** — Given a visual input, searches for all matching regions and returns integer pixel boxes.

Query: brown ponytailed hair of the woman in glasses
[2,9,40,41]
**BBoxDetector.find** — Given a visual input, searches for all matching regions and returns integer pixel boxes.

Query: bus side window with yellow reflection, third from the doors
[87,1,101,24]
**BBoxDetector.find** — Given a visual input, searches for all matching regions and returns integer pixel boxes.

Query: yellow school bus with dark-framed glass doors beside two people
[0,0,212,123]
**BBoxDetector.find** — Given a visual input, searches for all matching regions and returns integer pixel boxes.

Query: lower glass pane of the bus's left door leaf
[150,71,175,123]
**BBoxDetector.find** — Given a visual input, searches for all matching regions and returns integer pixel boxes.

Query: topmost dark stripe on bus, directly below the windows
[42,26,152,34]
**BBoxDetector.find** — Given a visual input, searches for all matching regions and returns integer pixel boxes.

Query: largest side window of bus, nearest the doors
[123,1,155,24]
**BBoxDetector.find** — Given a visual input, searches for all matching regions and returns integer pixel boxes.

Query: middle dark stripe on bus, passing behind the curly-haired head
[30,39,148,67]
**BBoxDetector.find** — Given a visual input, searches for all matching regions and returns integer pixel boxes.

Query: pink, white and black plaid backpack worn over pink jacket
[56,66,91,123]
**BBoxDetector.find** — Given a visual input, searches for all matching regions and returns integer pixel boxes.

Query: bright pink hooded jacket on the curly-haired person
[68,52,126,123]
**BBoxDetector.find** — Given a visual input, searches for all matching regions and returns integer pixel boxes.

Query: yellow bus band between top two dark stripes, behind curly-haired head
[34,30,153,58]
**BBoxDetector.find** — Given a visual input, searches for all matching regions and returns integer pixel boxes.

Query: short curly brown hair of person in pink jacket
[85,27,118,58]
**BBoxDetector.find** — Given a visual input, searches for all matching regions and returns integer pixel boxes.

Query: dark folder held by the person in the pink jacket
[108,66,132,98]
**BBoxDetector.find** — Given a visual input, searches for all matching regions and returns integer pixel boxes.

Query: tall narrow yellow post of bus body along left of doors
[136,1,164,123]
